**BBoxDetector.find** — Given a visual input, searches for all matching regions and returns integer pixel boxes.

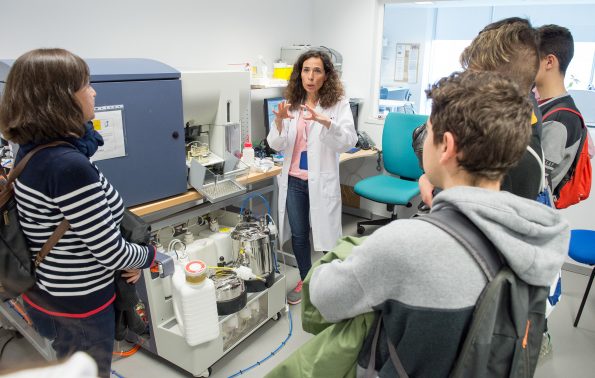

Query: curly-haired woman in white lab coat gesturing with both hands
[267,50,357,304]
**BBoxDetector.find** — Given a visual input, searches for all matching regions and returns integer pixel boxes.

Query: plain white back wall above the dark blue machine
[0,0,312,69]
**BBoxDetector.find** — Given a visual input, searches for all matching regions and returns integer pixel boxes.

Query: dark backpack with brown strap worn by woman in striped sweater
[0,142,70,299]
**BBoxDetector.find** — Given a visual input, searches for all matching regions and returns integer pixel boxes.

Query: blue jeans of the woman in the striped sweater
[25,302,116,377]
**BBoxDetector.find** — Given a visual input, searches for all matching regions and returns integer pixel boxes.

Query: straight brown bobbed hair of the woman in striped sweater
[0,49,89,144]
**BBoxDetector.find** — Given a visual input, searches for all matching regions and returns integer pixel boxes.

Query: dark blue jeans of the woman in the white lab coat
[286,176,312,280]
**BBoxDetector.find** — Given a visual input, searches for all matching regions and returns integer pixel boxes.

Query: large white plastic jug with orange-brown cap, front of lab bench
[172,260,219,346]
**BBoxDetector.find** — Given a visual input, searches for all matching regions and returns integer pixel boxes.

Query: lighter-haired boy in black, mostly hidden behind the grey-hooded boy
[419,17,542,205]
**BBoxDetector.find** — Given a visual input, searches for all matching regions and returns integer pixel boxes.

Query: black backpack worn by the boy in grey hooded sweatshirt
[368,208,549,378]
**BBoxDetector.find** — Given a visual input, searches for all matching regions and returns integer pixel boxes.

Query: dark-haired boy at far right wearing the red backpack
[535,25,582,195]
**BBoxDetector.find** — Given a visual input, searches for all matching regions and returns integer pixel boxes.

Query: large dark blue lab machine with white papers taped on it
[0,59,187,206]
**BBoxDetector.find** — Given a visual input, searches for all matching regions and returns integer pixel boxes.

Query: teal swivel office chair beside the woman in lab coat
[353,113,428,235]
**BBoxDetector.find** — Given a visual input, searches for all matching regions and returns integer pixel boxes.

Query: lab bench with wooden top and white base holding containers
[0,167,286,377]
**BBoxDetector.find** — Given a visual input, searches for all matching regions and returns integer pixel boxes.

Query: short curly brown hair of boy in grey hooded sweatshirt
[426,71,533,180]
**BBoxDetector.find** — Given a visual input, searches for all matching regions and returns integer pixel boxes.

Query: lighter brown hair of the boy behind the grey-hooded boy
[460,17,539,94]
